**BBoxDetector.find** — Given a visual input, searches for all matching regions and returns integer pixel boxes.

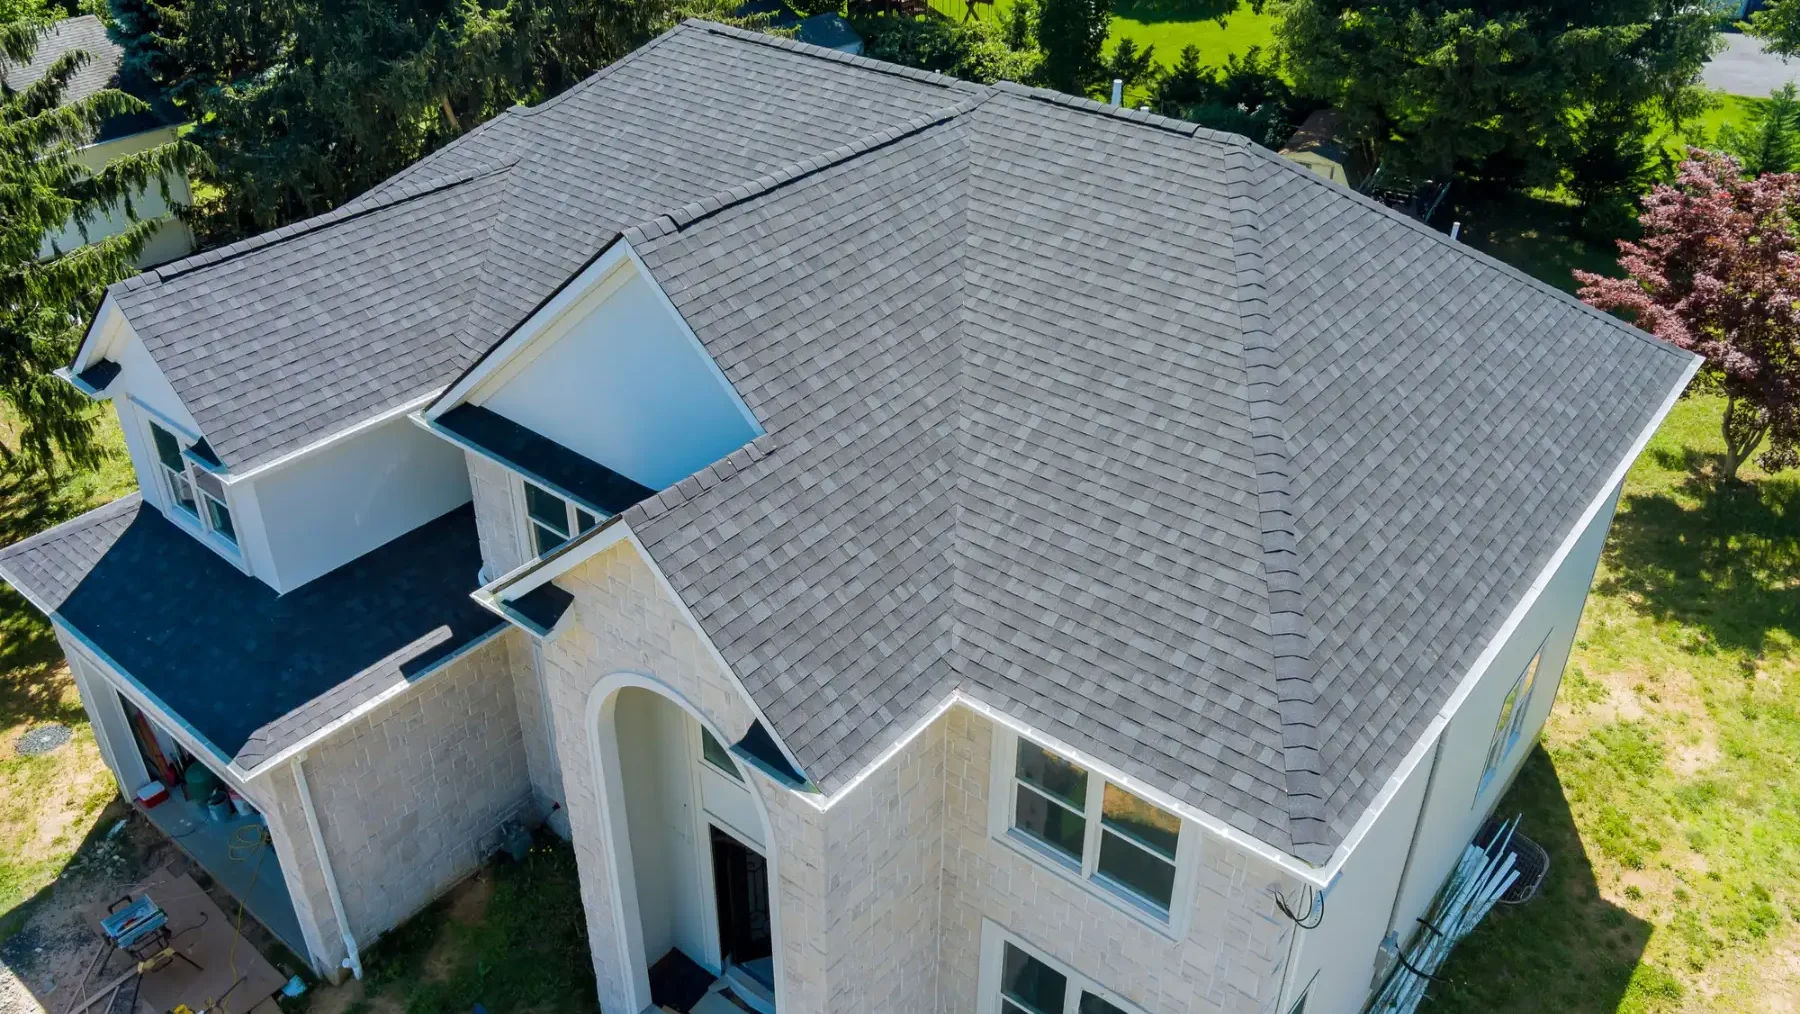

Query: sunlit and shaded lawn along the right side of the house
[1435,396,1800,1014]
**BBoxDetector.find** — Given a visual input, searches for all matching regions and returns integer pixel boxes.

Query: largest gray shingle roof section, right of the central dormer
[625,77,1690,861]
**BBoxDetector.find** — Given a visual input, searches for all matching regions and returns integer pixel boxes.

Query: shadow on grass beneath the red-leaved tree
[1598,448,1800,654]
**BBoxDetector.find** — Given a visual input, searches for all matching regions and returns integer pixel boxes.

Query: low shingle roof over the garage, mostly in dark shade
[0,493,504,767]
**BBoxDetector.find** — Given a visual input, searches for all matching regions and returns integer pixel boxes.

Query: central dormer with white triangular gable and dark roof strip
[418,240,761,576]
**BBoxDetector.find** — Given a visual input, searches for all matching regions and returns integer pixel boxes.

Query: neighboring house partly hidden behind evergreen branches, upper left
[0,14,194,267]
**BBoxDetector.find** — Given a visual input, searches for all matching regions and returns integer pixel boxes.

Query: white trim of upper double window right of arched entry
[988,724,1202,940]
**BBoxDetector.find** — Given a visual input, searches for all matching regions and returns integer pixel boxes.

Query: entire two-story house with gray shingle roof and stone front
[0,22,1697,1014]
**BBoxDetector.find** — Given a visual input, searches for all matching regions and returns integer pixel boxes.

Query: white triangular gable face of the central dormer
[473,263,756,490]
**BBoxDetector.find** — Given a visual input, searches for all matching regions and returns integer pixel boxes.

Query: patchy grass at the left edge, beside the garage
[0,412,135,926]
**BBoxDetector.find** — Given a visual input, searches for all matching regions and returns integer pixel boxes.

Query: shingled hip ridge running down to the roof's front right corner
[1226,137,1332,863]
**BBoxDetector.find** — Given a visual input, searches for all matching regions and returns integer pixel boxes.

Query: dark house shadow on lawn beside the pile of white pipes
[1426,746,1656,1014]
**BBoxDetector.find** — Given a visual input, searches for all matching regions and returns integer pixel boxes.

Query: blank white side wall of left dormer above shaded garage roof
[253,410,475,591]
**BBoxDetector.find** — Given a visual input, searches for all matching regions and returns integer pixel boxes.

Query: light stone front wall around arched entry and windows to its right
[544,544,1292,1014]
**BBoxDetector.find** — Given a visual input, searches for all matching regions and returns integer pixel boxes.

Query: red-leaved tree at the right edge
[1575,148,1800,479]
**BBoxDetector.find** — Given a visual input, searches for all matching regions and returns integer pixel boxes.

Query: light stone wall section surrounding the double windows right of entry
[938,708,1294,1014]
